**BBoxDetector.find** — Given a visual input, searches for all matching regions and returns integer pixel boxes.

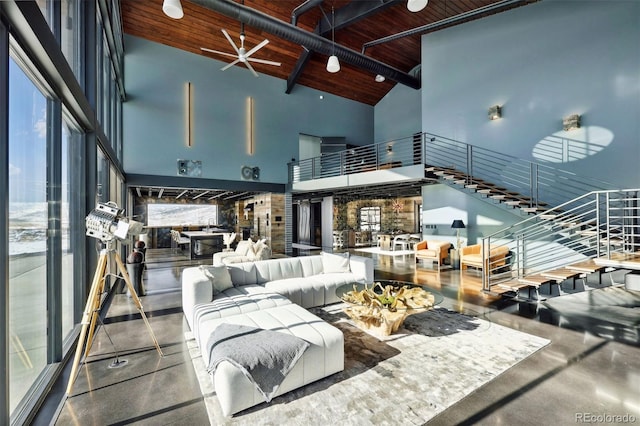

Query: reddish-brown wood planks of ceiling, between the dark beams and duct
[121,0,536,105]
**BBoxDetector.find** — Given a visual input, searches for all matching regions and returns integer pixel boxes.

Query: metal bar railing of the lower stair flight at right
[482,189,640,291]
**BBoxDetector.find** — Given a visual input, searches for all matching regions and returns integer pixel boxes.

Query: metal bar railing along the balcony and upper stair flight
[289,133,616,207]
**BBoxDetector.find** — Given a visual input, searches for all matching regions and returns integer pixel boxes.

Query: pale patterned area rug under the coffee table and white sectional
[186,304,549,426]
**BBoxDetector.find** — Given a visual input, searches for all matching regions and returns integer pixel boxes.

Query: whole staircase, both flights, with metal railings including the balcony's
[289,133,640,300]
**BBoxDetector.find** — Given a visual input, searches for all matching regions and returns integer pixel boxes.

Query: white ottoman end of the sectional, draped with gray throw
[195,304,344,416]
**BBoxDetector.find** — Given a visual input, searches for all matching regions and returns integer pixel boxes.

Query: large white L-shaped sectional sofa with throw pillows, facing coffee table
[182,253,373,416]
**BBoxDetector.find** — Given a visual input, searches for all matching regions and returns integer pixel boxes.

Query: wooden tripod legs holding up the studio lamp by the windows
[67,241,164,396]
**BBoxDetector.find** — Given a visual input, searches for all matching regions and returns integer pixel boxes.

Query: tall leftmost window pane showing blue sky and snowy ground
[9,55,48,412]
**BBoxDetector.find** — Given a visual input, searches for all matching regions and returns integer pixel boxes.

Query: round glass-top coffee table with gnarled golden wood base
[336,280,444,336]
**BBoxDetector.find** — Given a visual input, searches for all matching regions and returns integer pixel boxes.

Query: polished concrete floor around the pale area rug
[34,252,640,425]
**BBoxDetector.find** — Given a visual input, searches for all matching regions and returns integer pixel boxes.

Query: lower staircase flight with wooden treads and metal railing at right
[482,189,640,300]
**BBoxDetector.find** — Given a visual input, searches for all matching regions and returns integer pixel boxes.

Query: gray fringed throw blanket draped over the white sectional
[206,323,309,402]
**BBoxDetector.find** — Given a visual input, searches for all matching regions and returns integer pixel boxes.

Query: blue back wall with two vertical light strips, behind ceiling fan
[123,36,373,183]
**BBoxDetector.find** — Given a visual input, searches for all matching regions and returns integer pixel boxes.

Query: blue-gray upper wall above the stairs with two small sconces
[420,0,640,187]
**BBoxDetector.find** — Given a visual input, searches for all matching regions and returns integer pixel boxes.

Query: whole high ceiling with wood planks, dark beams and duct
[121,0,537,105]
